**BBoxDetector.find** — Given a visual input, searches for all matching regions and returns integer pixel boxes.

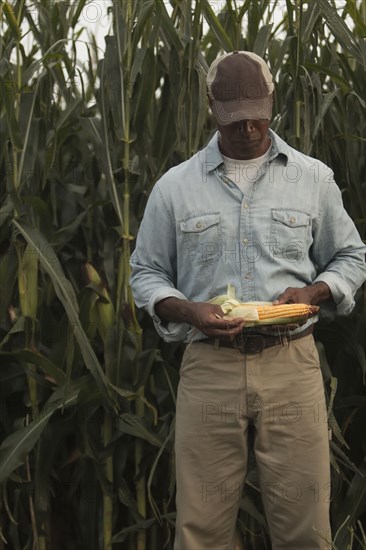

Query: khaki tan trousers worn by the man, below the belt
[174,335,330,550]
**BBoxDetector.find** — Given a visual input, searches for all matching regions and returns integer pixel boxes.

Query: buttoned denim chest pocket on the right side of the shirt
[271,208,311,262]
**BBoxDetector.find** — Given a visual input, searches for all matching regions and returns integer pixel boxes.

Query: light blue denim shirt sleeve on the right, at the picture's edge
[314,169,366,315]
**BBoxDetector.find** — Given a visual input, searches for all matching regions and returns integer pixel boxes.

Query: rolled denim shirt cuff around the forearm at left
[147,287,192,342]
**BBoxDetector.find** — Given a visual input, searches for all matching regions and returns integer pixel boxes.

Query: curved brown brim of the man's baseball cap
[211,96,272,126]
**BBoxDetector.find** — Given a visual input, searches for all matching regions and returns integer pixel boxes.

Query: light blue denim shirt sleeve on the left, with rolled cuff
[130,183,191,342]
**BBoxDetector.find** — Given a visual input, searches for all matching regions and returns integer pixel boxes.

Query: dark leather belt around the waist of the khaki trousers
[199,325,314,355]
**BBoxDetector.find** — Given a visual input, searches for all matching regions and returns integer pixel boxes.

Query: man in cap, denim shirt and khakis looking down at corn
[131,52,365,550]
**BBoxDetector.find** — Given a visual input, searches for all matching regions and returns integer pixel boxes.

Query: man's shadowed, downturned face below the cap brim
[217,116,271,160]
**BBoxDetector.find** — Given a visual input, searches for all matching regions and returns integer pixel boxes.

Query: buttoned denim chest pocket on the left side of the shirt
[179,212,222,264]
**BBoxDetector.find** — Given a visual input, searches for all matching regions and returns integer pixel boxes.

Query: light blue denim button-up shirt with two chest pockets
[131,130,366,341]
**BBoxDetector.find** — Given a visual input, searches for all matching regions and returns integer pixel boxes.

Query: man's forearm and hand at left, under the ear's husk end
[155,298,245,340]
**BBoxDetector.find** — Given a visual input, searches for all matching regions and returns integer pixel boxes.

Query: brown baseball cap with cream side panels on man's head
[206,51,274,126]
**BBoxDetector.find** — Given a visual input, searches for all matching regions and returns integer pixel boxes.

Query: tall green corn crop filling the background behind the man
[0,0,366,550]
